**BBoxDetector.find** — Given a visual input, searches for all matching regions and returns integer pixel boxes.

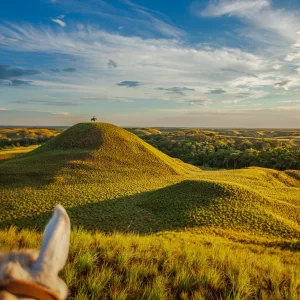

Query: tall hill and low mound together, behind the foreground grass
[0,123,300,244]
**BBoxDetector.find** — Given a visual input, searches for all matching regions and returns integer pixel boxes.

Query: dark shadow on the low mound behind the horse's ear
[0,180,224,234]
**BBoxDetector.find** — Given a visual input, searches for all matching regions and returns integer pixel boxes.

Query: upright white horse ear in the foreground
[33,205,71,275]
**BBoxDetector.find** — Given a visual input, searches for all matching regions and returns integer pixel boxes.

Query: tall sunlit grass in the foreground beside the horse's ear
[0,228,300,300]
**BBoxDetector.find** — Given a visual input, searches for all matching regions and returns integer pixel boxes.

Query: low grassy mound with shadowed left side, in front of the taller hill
[0,180,300,240]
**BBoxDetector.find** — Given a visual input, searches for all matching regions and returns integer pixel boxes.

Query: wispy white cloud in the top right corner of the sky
[197,0,300,70]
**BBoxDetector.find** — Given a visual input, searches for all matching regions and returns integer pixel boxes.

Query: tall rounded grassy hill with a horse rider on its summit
[0,122,199,183]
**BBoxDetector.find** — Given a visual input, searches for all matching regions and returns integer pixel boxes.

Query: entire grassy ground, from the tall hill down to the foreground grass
[0,123,300,299]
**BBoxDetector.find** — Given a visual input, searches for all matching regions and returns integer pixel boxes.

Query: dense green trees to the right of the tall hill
[141,130,300,170]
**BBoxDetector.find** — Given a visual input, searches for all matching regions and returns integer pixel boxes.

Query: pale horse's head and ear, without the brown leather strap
[0,205,71,300]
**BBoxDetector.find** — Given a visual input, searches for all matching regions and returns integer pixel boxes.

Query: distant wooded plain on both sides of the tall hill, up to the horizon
[0,128,300,170]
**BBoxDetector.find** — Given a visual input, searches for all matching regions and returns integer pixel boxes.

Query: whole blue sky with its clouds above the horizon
[0,0,300,128]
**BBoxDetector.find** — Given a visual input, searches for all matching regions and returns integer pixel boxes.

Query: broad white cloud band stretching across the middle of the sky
[0,8,300,116]
